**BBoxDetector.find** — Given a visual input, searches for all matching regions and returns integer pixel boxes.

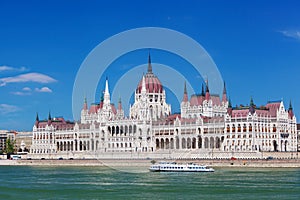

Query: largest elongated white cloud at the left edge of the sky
[0,73,57,86]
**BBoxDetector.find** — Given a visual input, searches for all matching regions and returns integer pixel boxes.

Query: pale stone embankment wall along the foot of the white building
[22,150,300,160]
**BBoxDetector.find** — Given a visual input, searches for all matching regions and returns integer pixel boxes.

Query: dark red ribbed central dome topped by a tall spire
[136,54,163,93]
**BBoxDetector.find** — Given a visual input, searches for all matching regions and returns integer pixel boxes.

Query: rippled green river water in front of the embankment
[0,166,300,200]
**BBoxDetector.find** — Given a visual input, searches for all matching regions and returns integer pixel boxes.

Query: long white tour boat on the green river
[149,162,215,172]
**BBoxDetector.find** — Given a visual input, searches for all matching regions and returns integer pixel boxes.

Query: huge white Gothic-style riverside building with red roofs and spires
[30,55,297,159]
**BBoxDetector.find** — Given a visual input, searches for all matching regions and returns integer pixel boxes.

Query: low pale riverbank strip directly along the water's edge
[0,159,300,168]
